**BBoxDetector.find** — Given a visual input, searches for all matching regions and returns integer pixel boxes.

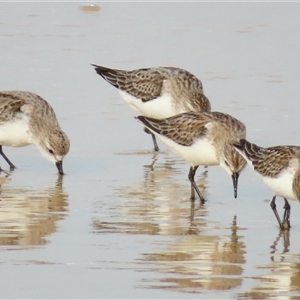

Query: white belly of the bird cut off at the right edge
[263,168,297,200]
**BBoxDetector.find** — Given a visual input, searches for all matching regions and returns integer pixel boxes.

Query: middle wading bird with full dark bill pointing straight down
[137,112,246,202]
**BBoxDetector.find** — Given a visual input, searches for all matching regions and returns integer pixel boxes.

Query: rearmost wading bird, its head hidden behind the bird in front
[92,64,211,151]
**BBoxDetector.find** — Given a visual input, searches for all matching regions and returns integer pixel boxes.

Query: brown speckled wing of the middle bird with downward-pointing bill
[137,112,208,146]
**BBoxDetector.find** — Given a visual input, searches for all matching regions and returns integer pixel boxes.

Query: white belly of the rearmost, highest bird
[119,90,185,119]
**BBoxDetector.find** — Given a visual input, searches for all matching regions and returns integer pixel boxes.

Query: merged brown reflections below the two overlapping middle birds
[93,154,245,293]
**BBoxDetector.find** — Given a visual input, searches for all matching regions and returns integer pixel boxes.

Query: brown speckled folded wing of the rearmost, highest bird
[93,65,164,102]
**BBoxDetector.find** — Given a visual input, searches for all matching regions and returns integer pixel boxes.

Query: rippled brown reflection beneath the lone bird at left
[0,176,68,245]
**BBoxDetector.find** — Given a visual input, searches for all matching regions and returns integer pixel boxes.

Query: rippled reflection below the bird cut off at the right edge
[240,230,300,299]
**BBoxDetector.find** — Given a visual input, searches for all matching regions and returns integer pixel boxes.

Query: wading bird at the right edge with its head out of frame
[234,139,300,229]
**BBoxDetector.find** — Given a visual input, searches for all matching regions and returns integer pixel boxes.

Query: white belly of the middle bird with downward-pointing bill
[157,135,220,166]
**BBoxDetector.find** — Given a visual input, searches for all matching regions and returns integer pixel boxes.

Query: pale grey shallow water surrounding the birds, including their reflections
[0,3,300,299]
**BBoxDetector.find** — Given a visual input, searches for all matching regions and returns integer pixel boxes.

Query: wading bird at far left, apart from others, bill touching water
[0,91,70,175]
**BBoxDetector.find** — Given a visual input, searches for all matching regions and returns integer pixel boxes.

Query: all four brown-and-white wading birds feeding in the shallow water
[0,64,300,230]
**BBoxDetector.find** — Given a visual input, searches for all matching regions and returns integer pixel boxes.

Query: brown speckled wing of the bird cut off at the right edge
[241,140,299,177]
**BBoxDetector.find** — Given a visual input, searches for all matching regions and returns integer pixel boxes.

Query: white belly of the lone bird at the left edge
[0,115,31,147]
